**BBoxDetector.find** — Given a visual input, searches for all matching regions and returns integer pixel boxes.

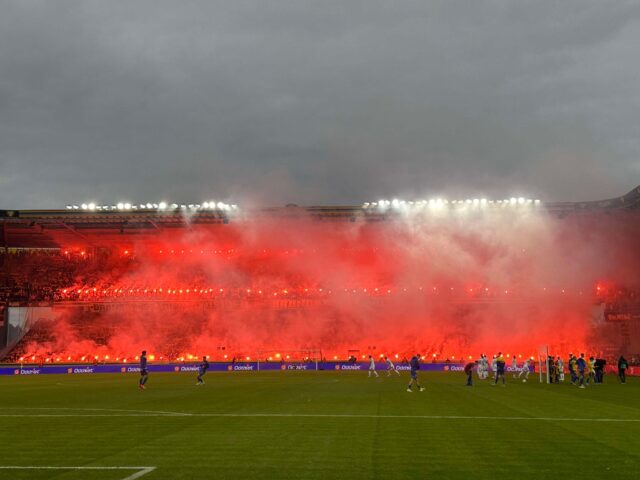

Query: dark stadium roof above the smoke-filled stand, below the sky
[0,186,640,249]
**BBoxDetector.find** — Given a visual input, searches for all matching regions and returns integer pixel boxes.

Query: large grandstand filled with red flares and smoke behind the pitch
[0,187,640,362]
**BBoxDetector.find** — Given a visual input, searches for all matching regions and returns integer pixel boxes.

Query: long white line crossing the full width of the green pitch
[0,407,640,423]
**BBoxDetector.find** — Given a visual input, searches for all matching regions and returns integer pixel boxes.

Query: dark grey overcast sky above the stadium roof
[0,0,640,208]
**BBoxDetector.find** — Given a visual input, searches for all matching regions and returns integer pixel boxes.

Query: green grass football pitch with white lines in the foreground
[0,371,640,480]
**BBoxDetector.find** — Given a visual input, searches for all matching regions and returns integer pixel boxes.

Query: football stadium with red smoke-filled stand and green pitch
[0,187,640,479]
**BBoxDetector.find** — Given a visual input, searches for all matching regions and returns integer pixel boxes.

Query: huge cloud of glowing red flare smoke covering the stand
[17,208,640,359]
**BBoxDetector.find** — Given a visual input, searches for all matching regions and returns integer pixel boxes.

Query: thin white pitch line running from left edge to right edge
[0,409,640,423]
